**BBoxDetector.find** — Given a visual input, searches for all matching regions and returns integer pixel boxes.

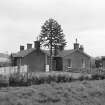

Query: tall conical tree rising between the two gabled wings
[39,18,66,70]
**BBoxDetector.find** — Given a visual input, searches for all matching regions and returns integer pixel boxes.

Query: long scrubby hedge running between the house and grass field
[9,72,105,86]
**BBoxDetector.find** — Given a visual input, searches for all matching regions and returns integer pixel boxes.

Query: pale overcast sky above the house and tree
[0,0,105,57]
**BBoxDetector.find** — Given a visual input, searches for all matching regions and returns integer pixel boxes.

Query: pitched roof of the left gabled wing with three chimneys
[12,48,49,57]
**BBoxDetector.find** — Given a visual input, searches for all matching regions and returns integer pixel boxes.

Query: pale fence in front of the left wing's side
[0,65,28,76]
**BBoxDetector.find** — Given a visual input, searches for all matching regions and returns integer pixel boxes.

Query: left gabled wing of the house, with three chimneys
[11,41,49,72]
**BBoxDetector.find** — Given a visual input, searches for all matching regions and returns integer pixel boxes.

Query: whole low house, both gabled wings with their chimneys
[11,41,90,71]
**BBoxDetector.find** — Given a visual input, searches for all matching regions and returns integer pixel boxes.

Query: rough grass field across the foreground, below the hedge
[0,80,105,105]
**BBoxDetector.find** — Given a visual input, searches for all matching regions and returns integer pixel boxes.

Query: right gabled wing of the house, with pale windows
[55,41,91,71]
